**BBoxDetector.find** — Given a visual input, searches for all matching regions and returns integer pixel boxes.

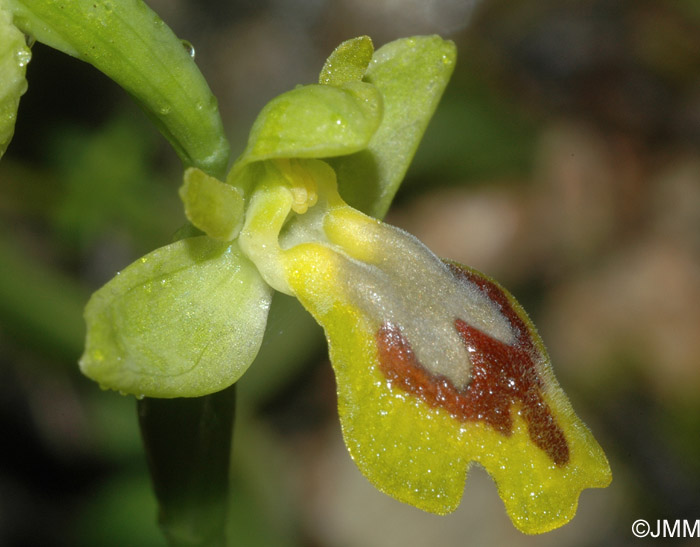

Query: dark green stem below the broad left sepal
[138,384,236,547]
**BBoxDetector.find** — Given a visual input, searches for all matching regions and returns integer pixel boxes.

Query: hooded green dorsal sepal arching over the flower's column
[236,82,382,167]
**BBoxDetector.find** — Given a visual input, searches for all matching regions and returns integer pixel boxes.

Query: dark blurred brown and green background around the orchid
[0,0,700,547]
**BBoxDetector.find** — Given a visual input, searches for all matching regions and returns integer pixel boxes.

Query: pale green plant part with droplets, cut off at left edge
[0,7,32,158]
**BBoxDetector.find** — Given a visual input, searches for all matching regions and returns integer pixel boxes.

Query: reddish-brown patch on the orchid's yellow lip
[376,263,569,466]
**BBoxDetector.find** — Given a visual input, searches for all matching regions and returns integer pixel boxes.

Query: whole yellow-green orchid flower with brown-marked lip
[80,37,611,533]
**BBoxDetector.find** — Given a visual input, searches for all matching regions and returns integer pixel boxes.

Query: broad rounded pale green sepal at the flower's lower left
[80,236,272,397]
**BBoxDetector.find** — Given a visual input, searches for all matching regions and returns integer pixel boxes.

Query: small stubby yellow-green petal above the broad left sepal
[180,167,244,241]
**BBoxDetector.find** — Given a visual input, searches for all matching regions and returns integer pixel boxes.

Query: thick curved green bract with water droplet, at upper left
[4,0,229,177]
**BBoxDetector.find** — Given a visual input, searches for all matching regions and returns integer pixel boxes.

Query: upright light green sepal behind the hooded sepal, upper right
[330,36,456,217]
